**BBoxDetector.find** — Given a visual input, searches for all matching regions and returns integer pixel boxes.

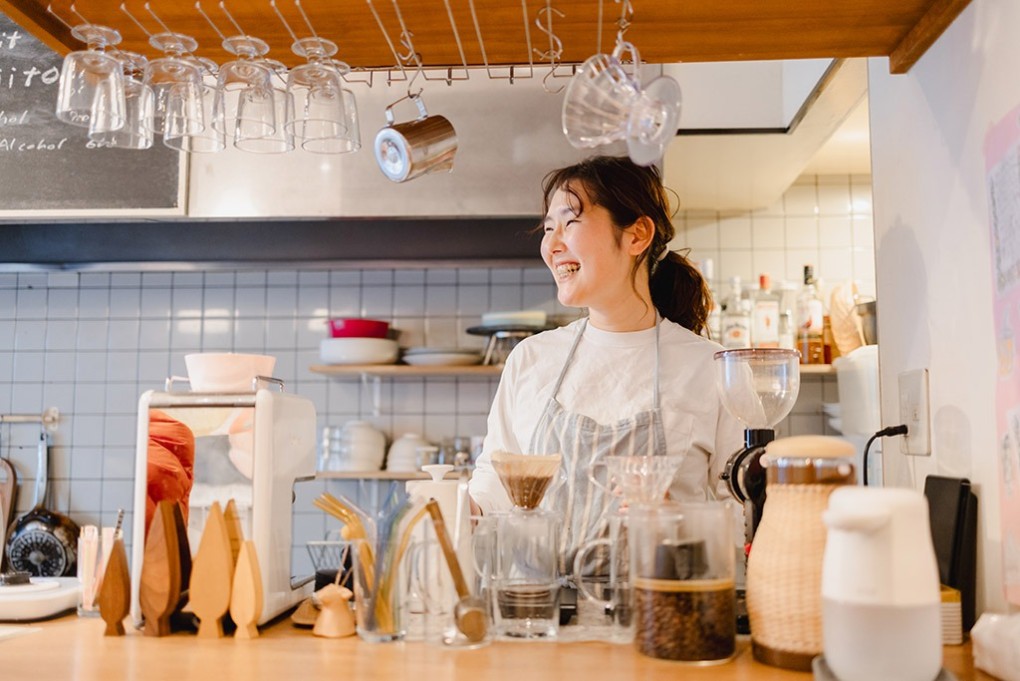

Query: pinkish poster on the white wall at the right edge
[984,106,1020,605]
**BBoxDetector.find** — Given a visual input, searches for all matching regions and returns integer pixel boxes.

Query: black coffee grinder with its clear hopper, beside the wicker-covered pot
[715,348,801,543]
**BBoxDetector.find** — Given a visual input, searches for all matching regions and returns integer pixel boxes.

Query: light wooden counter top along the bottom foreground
[0,616,992,681]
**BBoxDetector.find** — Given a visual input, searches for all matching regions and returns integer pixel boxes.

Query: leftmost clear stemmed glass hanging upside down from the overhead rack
[56,23,126,134]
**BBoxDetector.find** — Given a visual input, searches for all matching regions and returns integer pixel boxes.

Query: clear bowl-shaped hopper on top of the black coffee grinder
[715,348,801,430]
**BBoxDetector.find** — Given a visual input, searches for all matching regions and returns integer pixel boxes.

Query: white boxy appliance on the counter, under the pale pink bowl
[132,377,315,624]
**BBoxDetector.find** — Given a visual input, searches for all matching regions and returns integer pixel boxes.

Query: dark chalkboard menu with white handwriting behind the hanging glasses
[0,14,184,215]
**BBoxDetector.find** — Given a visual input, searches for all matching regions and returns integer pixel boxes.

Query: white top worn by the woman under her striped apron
[470,320,744,512]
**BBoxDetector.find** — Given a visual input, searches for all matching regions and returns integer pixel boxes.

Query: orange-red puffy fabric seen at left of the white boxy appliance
[145,409,195,536]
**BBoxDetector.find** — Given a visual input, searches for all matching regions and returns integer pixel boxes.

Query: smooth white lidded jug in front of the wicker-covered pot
[822,487,942,681]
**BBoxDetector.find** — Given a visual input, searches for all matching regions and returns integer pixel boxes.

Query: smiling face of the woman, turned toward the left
[542,189,635,313]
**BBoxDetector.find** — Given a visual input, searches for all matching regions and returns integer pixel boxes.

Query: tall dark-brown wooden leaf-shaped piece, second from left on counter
[140,501,181,636]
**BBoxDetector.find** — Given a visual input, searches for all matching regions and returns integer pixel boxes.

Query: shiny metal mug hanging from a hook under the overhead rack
[375,94,457,182]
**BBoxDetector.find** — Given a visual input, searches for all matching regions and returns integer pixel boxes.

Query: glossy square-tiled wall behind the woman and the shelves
[0,175,874,561]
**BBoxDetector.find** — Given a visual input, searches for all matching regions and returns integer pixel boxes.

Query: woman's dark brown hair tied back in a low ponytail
[542,156,712,333]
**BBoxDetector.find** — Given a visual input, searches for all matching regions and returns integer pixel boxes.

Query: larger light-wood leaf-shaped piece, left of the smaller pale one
[188,502,234,638]
